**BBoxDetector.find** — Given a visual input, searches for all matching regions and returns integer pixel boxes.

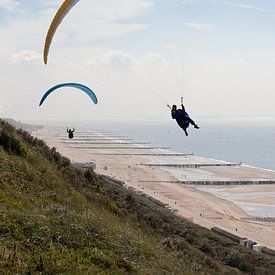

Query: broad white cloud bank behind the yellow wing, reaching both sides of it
[0,0,152,58]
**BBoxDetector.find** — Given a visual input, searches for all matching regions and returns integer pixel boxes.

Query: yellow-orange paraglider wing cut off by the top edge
[44,0,80,64]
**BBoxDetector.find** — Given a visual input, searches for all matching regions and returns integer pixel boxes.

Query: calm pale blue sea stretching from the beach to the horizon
[73,120,275,170]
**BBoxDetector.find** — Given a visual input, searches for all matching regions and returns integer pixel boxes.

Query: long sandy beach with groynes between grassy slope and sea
[33,127,275,249]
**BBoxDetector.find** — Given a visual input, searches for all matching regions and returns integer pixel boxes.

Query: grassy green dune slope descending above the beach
[0,121,275,274]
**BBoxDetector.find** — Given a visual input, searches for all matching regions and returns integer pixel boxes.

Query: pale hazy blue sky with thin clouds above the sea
[0,0,275,120]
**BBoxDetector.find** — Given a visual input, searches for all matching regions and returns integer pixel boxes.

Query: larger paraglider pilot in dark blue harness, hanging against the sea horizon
[167,98,200,136]
